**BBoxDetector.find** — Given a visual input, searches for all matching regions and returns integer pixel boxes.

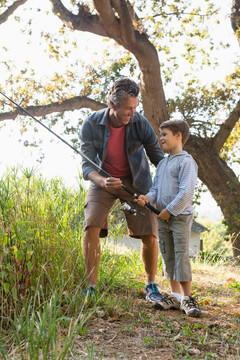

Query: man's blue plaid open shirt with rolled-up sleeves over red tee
[80,108,164,194]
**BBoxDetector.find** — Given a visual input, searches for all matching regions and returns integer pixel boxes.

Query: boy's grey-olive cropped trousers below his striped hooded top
[158,214,193,282]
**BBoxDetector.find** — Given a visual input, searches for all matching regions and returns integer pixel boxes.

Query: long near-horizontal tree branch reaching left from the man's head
[0,96,107,121]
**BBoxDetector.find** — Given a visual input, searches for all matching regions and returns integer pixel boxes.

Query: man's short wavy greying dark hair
[108,78,140,106]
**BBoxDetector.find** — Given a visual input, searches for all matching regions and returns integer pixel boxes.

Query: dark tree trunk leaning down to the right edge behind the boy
[185,136,240,258]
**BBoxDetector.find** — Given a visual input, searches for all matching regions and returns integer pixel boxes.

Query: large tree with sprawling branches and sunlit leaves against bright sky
[0,0,240,256]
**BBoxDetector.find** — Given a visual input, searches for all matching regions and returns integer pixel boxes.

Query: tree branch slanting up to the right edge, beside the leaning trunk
[212,100,240,153]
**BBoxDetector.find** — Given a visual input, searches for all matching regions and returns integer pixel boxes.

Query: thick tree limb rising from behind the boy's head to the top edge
[50,0,168,126]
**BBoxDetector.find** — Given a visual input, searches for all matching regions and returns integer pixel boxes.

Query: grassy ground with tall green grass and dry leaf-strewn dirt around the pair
[0,168,240,360]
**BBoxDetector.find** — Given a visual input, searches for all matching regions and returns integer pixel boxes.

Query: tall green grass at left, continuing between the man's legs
[0,168,143,360]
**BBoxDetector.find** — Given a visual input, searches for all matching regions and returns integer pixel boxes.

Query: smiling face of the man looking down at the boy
[109,96,138,127]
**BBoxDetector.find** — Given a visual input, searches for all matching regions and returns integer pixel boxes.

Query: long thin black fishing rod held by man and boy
[0,91,159,215]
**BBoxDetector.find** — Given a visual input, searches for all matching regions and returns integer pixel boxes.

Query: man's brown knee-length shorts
[84,177,158,239]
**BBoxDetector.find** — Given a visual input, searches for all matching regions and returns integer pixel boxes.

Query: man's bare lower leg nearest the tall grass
[82,226,101,286]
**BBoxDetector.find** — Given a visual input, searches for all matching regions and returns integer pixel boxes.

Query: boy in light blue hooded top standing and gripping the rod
[136,120,201,317]
